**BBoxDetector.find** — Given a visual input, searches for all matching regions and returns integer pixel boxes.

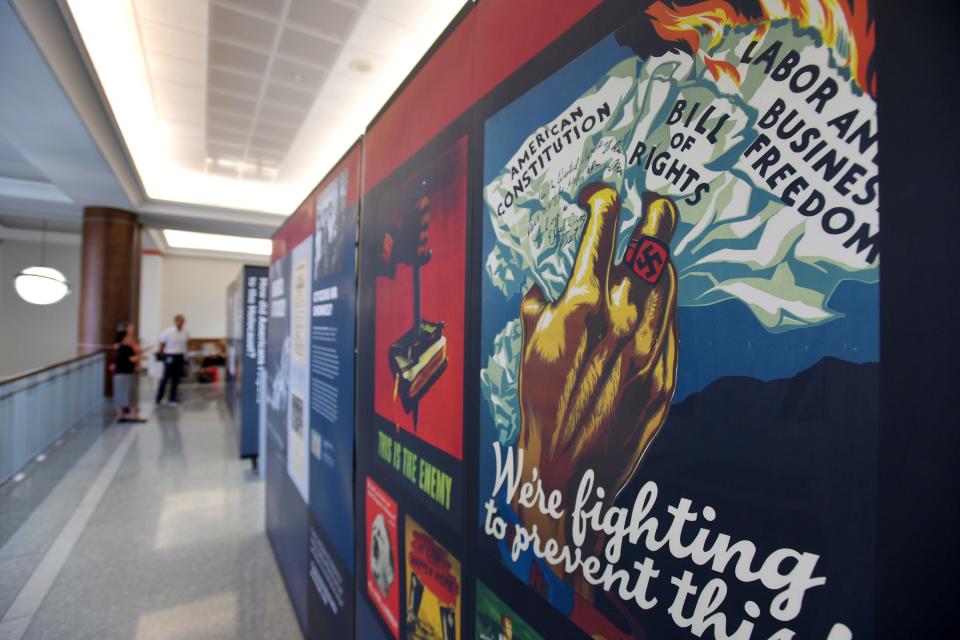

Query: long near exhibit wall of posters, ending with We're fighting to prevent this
[266,0,916,640]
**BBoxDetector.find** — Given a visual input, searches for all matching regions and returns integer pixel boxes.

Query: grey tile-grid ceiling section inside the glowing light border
[134,0,366,180]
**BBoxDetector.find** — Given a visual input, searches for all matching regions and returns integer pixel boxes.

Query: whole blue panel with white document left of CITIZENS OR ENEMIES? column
[266,142,360,638]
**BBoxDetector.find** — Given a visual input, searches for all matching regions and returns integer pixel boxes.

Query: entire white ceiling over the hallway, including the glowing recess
[0,0,463,249]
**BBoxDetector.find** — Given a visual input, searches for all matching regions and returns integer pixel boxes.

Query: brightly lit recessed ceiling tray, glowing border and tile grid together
[60,0,464,216]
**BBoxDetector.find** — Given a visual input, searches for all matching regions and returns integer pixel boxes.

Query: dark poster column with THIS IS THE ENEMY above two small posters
[356,129,467,638]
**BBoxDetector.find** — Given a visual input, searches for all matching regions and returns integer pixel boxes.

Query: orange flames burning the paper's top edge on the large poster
[647,0,877,96]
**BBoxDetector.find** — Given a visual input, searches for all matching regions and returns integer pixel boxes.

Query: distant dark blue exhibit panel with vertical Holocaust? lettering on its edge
[225,265,269,460]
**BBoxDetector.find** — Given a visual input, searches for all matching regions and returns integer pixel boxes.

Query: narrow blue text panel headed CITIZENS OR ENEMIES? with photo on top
[308,147,359,638]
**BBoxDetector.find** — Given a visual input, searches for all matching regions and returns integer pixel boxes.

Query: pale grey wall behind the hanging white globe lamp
[0,236,80,377]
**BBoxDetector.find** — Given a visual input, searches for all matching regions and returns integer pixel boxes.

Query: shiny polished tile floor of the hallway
[0,387,302,640]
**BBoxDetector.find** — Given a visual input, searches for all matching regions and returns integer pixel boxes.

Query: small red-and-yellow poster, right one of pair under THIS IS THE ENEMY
[404,516,461,640]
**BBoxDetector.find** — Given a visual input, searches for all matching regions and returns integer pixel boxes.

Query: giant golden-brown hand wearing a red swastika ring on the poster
[518,183,678,560]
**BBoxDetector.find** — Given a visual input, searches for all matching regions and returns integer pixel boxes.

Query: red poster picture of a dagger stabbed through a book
[374,138,466,462]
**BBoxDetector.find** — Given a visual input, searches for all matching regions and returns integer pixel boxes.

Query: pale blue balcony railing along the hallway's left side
[0,352,106,484]
